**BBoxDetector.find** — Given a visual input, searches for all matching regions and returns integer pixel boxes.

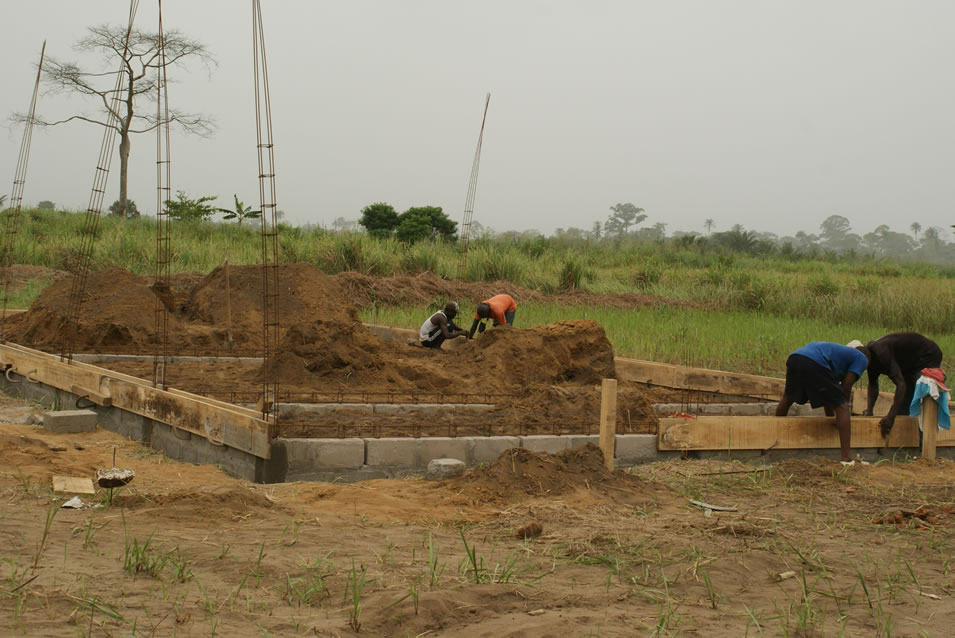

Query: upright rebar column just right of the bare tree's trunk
[153,0,172,390]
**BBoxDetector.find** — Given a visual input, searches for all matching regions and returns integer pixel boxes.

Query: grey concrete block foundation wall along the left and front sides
[0,374,955,483]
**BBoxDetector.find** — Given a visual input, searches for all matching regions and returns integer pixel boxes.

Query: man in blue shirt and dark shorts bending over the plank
[776,341,869,464]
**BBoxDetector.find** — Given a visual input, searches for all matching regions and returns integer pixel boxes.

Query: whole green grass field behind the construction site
[7,210,955,384]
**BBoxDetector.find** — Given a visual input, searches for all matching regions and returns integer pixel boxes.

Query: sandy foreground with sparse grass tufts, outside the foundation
[0,392,955,637]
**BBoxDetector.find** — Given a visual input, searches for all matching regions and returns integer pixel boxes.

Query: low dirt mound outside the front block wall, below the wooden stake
[444,443,643,502]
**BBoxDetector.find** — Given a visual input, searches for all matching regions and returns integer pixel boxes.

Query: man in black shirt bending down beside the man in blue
[864,332,942,437]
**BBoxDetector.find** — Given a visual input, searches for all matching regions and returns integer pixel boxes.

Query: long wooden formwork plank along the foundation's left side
[0,343,272,459]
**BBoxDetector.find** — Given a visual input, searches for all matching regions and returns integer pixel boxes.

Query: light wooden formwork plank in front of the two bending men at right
[657,416,955,450]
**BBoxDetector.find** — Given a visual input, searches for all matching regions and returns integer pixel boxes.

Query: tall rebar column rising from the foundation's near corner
[252,0,280,431]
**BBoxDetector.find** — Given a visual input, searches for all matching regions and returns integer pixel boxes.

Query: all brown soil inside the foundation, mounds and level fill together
[4,264,732,437]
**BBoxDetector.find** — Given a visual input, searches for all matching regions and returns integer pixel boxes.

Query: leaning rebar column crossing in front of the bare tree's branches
[60,0,139,363]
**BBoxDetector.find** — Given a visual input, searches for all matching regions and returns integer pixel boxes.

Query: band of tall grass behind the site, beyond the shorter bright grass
[7,210,955,342]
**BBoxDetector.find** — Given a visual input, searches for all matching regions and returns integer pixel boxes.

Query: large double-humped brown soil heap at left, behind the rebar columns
[5,264,358,354]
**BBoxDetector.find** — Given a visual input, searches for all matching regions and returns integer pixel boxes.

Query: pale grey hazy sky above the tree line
[0,0,955,238]
